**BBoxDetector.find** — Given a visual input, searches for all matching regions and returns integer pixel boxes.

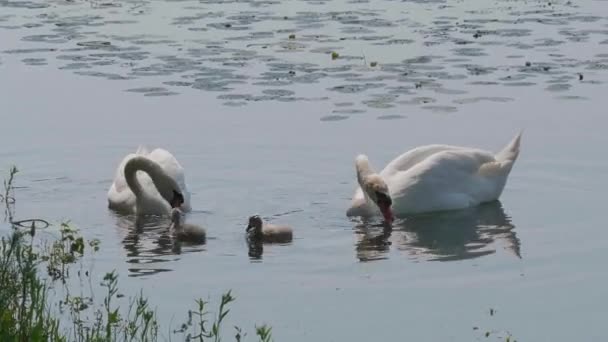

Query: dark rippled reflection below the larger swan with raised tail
[355,201,521,262]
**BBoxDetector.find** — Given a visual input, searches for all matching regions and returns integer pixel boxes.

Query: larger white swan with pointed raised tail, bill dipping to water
[346,132,522,223]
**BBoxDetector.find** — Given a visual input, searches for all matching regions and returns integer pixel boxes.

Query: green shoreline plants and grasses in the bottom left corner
[0,167,272,342]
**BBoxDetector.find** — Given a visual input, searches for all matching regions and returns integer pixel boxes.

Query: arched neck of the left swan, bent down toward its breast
[125,156,170,200]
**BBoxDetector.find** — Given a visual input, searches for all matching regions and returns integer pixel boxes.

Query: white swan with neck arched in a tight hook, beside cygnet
[108,147,191,215]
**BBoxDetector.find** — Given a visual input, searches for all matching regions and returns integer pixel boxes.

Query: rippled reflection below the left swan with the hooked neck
[109,214,205,277]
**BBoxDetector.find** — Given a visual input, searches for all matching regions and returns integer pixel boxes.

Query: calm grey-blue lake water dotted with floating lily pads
[0,0,608,341]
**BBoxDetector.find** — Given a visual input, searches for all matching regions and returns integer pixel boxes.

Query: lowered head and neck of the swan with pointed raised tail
[355,154,395,224]
